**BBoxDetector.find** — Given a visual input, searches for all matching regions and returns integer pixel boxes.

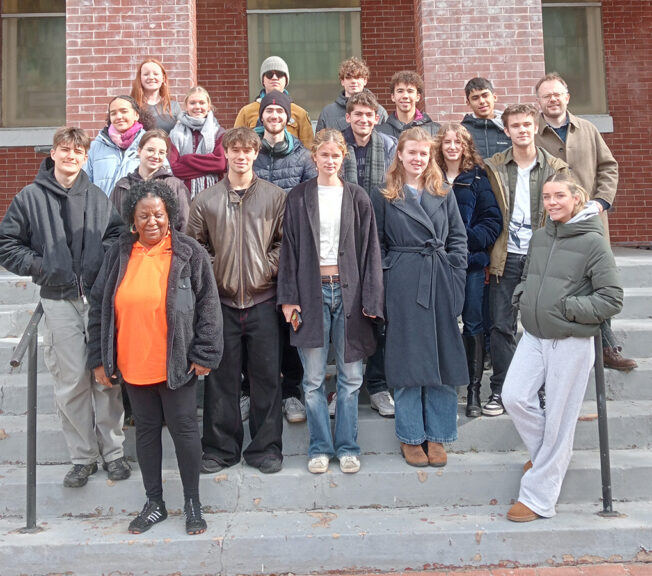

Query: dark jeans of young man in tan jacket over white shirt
[489,252,526,394]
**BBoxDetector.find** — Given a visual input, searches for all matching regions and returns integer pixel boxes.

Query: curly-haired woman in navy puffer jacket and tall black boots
[435,123,503,417]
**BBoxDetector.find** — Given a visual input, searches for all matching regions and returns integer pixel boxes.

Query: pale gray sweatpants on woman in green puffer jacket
[502,332,595,518]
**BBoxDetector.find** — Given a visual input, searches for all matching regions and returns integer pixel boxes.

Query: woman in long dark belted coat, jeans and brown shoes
[371,128,468,466]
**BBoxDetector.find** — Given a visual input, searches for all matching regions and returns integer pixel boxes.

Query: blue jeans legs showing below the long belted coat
[394,385,457,446]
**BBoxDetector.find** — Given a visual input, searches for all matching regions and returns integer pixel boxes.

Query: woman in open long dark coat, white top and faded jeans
[277,130,383,474]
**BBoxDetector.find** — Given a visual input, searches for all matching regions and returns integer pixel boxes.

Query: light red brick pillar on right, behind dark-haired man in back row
[415,0,545,121]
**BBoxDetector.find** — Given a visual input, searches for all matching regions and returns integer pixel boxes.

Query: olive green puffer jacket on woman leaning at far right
[513,208,623,339]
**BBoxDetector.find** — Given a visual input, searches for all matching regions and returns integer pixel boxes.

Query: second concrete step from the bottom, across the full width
[0,450,652,517]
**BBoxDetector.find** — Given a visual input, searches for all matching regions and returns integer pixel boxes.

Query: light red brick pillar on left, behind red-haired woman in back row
[66,0,197,134]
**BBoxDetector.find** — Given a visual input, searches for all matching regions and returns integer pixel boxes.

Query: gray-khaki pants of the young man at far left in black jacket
[41,298,124,464]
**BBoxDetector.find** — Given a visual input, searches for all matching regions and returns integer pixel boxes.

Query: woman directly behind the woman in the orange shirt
[110,129,190,232]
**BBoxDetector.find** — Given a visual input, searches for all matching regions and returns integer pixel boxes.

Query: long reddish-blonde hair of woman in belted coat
[382,126,447,202]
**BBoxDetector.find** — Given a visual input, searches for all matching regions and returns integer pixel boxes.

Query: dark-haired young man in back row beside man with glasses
[462,77,512,158]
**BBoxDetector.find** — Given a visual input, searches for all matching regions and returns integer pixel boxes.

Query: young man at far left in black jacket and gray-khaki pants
[0,127,131,488]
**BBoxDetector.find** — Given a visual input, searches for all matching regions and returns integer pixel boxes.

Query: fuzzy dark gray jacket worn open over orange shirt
[87,229,224,390]
